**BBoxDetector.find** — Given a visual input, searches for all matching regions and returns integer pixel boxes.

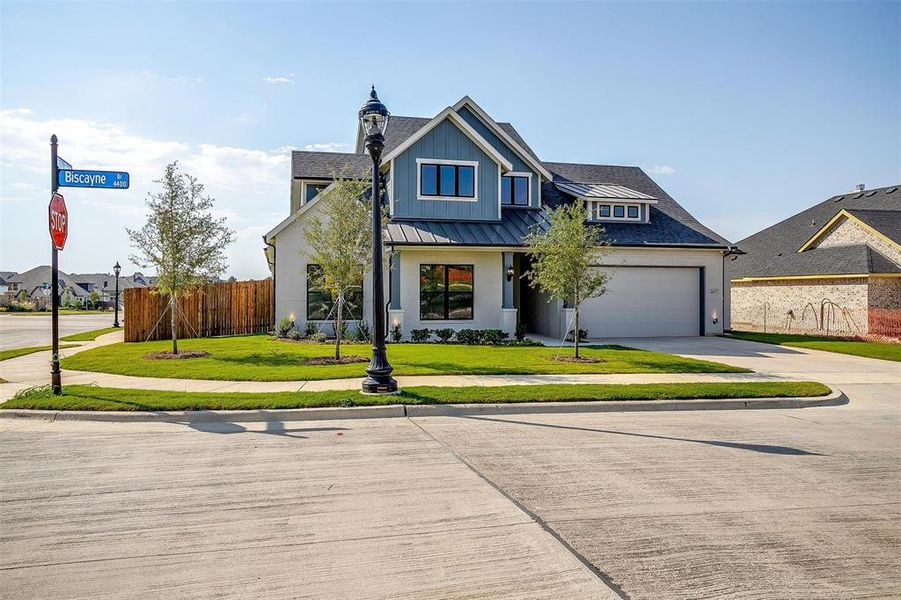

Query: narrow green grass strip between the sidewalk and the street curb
[0,382,830,411]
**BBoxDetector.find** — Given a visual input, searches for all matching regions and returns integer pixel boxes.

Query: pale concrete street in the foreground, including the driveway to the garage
[0,339,901,599]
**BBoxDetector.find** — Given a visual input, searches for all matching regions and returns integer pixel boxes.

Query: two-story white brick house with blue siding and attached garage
[264,96,734,338]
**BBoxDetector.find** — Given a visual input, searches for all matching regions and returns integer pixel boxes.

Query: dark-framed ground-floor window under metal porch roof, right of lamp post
[419,265,475,321]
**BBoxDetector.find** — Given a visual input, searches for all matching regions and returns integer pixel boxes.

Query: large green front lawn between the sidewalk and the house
[63,335,747,381]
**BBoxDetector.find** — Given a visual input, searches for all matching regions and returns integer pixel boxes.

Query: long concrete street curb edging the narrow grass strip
[0,390,849,423]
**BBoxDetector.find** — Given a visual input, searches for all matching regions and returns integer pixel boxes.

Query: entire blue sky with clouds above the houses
[0,1,901,277]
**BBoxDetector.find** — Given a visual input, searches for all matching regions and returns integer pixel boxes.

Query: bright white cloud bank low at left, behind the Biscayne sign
[0,109,291,278]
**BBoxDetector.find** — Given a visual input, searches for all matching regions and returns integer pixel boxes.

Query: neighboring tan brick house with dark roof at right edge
[729,186,901,337]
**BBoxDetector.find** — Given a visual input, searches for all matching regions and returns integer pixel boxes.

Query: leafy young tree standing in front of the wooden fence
[126,162,234,354]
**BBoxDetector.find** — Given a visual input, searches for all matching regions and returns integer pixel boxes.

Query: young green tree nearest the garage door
[526,201,609,358]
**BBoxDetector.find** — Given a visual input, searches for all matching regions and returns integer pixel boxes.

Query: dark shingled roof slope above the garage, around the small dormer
[541,162,732,248]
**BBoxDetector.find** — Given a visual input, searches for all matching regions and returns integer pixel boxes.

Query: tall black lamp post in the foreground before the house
[360,86,397,394]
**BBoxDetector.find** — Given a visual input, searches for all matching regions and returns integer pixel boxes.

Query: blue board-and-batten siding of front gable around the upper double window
[392,119,500,221]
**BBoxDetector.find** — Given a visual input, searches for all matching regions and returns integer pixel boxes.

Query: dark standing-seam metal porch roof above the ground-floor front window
[385,210,548,247]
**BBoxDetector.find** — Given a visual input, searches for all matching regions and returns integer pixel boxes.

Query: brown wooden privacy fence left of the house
[124,279,274,342]
